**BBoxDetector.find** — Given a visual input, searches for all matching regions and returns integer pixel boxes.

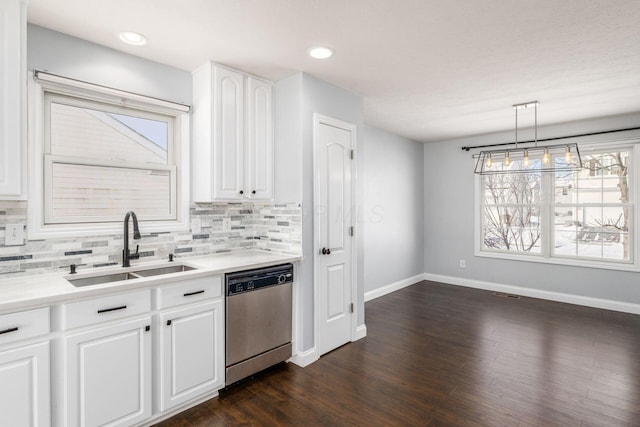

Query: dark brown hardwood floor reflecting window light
[159,282,640,427]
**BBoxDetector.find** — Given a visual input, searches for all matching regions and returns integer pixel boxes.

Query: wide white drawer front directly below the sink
[63,289,151,329]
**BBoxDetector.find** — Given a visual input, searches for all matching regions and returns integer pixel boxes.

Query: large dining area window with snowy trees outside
[476,143,638,269]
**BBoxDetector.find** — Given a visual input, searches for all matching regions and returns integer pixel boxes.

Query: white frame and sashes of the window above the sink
[27,72,190,239]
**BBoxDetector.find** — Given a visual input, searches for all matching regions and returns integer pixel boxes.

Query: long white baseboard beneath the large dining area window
[424,273,640,314]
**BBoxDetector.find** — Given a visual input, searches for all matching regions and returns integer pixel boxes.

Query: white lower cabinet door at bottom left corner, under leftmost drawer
[0,341,51,427]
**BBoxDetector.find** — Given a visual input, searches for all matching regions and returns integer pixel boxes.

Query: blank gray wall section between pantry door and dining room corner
[359,125,425,293]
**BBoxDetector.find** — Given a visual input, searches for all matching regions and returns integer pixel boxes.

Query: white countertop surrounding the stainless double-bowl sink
[0,250,302,314]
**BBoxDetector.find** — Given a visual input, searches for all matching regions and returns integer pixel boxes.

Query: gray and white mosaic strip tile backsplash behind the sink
[0,201,302,276]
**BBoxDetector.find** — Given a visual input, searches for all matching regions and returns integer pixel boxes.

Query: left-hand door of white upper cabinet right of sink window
[215,66,245,200]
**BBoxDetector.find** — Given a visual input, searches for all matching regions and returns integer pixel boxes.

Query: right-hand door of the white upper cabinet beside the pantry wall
[245,77,273,200]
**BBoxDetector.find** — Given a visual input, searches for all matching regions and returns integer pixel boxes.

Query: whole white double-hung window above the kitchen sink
[30,73,188,237]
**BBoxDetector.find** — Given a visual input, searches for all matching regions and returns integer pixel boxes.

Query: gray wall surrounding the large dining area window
[424,110,640,304]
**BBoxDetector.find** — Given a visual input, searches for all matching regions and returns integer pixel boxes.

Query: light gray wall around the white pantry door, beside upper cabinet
[274,73,364,351]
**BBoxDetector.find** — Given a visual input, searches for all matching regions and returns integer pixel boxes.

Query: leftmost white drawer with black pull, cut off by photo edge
[0,307,51,345]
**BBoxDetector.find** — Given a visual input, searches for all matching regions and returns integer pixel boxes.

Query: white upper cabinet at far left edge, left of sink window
[0,0,27,200]
